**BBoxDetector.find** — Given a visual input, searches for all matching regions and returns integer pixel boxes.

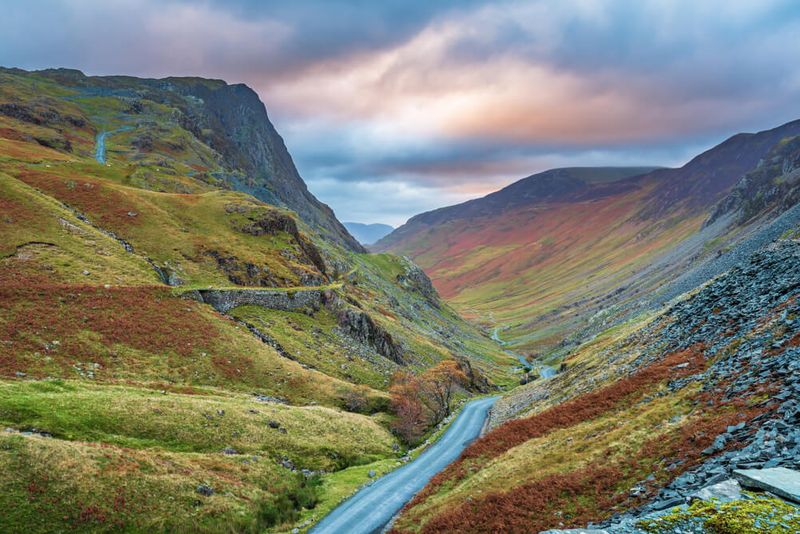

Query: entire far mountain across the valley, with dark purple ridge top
[372,121,800,357]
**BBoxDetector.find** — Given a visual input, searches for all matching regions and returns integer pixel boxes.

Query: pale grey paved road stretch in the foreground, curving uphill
[311,397,497,534]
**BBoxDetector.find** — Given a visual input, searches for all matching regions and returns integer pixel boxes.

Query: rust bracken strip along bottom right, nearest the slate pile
[410,403,766,534]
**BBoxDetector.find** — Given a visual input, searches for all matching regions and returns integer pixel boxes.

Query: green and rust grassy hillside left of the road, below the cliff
[0,70,514,532]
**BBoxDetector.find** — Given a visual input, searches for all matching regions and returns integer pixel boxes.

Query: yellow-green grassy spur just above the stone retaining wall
[6,168,321,286]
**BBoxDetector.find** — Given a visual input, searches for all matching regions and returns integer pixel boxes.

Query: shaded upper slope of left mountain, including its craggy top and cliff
[0,69,363,251]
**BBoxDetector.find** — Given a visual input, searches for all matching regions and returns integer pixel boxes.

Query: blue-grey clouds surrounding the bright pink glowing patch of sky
[0,0,800,224]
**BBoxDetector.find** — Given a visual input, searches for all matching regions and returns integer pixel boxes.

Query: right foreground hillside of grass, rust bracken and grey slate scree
[395,241,800,533]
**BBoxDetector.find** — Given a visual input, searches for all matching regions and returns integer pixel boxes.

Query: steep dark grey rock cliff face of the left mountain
[28,69,364,252]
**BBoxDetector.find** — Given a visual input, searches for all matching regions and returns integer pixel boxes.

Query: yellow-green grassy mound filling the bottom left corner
[0,434,318,533]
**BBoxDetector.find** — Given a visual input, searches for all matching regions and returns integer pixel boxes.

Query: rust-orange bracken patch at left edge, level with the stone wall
[0,279,218,376]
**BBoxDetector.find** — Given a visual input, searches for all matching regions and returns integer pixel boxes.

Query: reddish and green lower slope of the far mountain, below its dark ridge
[382,179,704,354]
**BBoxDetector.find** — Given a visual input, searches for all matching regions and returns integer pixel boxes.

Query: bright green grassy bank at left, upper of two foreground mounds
[0,381,395,470]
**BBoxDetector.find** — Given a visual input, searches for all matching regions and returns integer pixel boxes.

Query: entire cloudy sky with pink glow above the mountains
[0,0,800,225]
